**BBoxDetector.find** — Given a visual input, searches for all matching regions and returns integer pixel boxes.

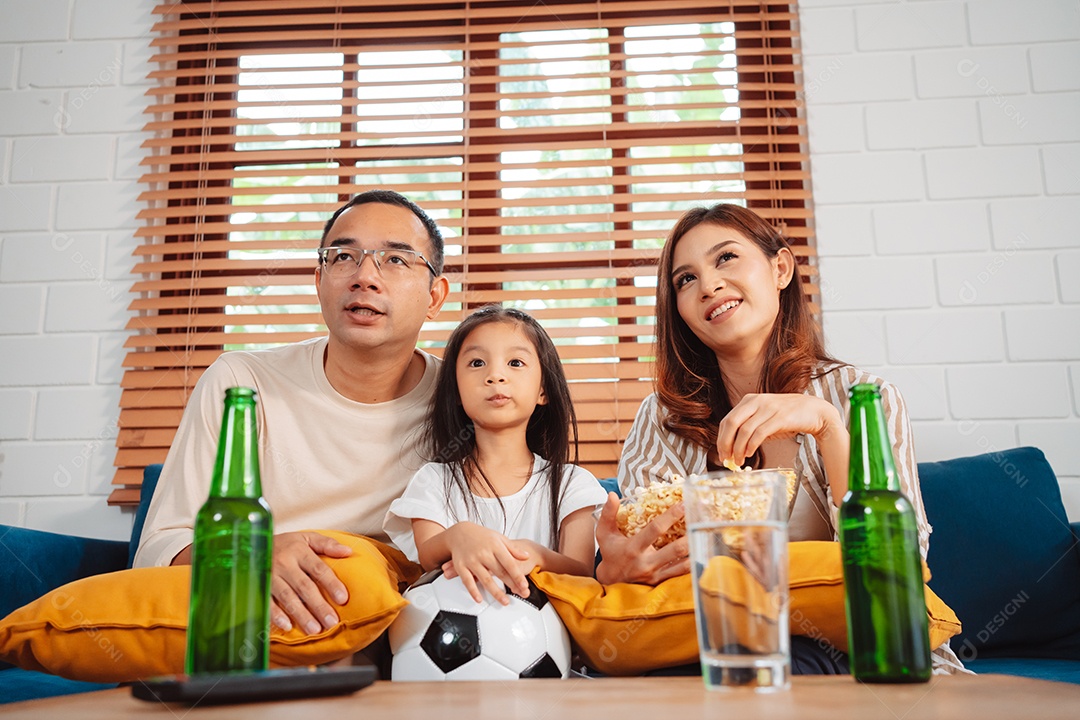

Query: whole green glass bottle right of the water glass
[839,384,931,682]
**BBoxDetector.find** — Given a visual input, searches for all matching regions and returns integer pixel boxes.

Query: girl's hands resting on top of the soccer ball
[443,522,536,604]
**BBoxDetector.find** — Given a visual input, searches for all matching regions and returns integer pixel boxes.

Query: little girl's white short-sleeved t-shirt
[382,454,607,562]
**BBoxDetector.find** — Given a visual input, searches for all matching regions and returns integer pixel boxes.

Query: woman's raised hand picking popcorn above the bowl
[716,393,848,465]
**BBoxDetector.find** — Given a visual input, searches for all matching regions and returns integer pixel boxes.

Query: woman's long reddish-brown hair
[656,203,837,465]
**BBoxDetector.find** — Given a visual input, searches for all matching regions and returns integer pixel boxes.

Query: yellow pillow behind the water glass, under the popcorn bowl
[532,542,960,675]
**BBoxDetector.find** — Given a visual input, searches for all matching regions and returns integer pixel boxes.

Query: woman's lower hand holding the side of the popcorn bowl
[596,492,690,585]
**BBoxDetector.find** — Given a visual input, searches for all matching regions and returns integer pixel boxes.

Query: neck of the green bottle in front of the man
[210,388,262,498]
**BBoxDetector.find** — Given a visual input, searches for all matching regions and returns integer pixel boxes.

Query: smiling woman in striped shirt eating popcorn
[596,204,959,667]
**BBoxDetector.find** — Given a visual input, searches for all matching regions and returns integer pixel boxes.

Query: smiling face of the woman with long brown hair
[671,222,795,354]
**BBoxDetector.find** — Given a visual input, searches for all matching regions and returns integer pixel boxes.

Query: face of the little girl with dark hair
[456,322,548,430]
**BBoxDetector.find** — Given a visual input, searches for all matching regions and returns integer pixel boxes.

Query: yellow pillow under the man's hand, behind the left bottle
[0,530,420,682]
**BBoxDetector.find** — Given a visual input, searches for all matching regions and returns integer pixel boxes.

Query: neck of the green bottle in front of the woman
[848,384,900,492]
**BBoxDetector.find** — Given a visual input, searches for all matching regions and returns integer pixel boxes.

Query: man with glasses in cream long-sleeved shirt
[135,190,449,634]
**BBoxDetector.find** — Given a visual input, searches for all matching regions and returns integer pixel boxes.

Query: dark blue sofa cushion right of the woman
[919,448,1080,662]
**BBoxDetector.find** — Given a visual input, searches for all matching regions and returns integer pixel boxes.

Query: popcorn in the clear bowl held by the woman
[616,459,798,549]
